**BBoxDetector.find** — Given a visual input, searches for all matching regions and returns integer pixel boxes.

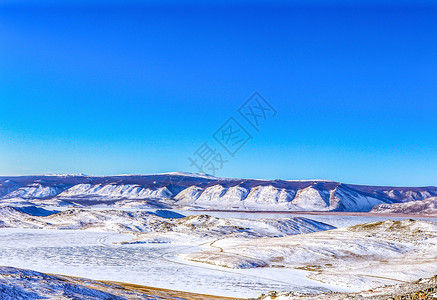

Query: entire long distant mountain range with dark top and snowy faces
[0,172,437,212]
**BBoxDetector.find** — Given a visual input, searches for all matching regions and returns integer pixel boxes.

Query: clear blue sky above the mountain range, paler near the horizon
[0,0,437,186]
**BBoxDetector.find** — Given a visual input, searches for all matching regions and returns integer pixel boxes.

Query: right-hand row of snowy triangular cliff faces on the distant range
[175,184,392,211]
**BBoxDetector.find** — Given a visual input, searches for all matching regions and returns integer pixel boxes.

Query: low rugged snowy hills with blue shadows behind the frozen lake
[0,206,335,238]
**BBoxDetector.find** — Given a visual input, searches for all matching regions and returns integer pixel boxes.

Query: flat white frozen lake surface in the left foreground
[0,228,344,297]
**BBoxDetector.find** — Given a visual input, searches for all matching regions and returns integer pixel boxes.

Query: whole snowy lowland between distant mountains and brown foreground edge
[0,207,437,297]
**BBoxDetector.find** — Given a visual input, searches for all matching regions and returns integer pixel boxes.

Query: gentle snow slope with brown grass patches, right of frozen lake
[182,220,437,289]
